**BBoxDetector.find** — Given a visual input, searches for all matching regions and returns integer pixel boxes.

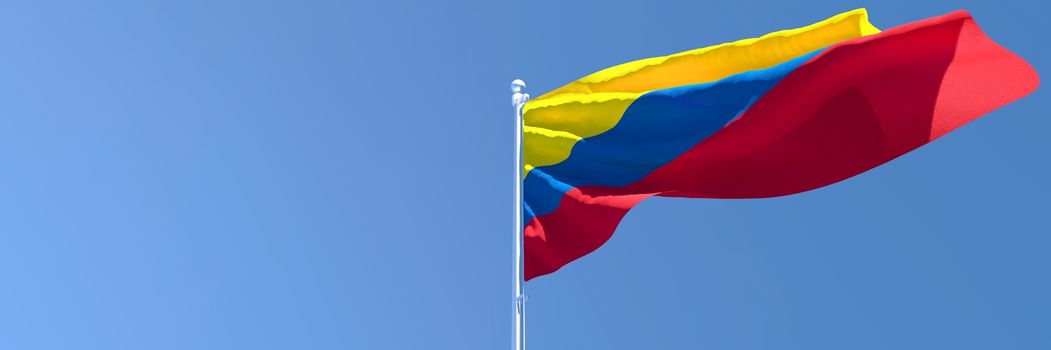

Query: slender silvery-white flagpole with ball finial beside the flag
[511,79,529,350]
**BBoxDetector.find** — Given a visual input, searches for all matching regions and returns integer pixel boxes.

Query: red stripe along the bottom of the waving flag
[526,12,1039,280]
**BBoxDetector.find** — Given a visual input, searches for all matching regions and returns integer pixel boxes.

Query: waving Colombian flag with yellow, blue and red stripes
[522,9,1039,280]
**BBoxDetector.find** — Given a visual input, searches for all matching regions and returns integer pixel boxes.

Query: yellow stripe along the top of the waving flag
[522,8,880,173]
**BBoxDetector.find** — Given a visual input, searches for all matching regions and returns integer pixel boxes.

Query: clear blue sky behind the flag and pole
[0,0,1051,350]
